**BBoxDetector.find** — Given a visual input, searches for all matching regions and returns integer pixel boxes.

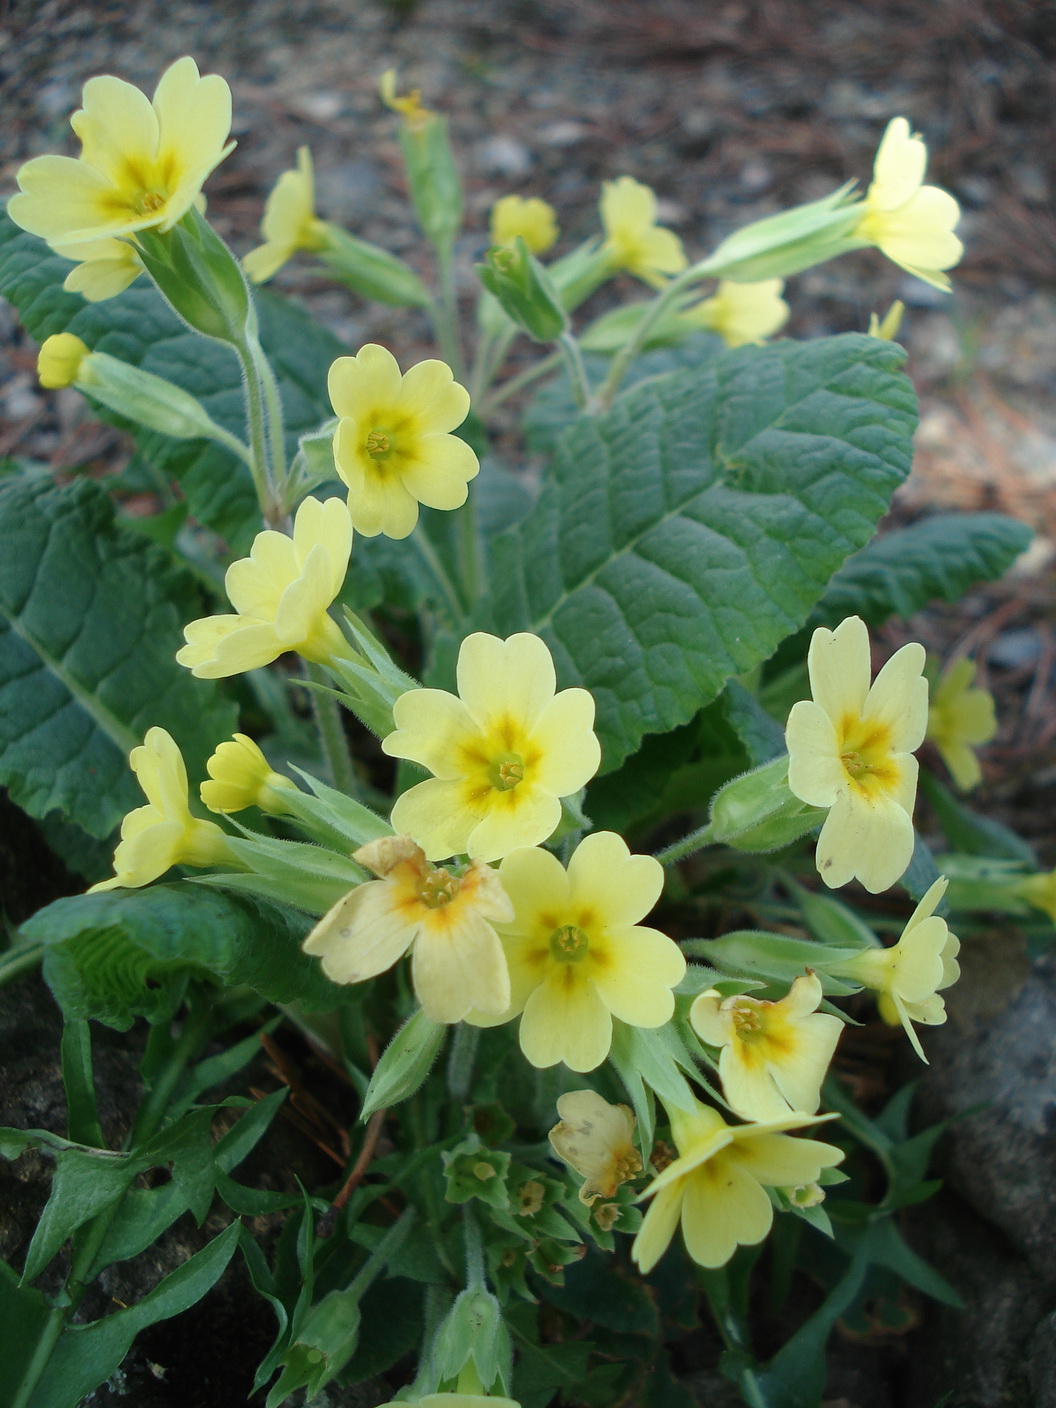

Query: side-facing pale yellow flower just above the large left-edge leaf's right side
[176,498,352,680]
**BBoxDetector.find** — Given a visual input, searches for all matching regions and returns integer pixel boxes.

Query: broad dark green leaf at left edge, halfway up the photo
[0,476,237,836]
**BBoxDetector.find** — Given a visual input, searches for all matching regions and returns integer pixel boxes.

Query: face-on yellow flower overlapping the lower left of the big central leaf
[382,631,601,860]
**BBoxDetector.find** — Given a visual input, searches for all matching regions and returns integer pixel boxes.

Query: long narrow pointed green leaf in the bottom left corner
[32,1222,239,1408]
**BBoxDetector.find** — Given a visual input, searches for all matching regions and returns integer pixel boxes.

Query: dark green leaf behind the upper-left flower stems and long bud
[0,214,348,551]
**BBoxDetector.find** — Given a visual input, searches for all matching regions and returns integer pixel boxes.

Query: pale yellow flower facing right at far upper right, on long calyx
[853,117,964,290]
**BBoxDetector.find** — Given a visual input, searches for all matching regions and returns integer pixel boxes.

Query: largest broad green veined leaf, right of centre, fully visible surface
[482,335,915,772]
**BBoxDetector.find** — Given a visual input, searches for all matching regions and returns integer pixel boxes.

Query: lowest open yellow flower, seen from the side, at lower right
[631,1102,843,1273]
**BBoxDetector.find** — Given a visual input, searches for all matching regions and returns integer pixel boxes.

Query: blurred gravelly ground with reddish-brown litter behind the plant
[0,0,1056,1408]
